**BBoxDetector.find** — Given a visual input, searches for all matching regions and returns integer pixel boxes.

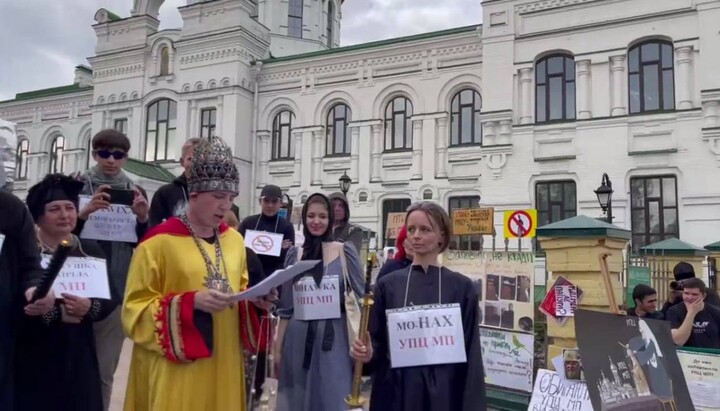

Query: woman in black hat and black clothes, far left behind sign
[16,174,115,411]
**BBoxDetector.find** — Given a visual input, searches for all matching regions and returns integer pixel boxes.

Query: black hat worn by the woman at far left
[25,174,84,222]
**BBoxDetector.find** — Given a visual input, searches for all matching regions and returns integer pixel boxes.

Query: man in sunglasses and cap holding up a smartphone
[74,129,150,410]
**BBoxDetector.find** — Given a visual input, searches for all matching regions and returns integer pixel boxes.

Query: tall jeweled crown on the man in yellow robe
[188,137,240,194]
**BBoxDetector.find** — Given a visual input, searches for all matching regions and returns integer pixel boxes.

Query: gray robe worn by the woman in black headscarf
[276,243,365,411]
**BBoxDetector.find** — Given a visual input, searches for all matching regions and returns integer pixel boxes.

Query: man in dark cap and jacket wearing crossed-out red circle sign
[239,184,295,275]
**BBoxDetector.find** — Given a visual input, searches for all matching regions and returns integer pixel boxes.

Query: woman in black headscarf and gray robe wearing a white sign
[273,194,364,411]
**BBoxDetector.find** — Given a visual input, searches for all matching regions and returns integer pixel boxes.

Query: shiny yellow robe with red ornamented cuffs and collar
[122,219,248,411]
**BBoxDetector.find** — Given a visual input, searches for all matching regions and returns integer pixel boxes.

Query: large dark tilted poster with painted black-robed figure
[575,310,695,411]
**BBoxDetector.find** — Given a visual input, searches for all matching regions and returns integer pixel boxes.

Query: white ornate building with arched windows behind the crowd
[0,0,720,253]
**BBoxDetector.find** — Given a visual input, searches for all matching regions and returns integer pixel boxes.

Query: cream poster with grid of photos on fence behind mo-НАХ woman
[442,250,535,333]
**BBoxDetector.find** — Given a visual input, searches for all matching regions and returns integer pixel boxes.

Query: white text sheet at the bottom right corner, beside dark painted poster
[678,349,720,411]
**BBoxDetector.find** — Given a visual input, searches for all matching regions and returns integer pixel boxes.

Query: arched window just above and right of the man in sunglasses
[145,98,180,161]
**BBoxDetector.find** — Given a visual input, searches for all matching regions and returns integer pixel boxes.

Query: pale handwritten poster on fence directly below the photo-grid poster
[480,327,535,393]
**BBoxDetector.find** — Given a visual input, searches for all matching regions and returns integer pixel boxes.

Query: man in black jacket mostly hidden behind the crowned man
[150,138,240,227]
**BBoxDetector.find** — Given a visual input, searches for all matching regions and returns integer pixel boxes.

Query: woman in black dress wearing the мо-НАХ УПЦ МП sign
[351,202,487,411]
